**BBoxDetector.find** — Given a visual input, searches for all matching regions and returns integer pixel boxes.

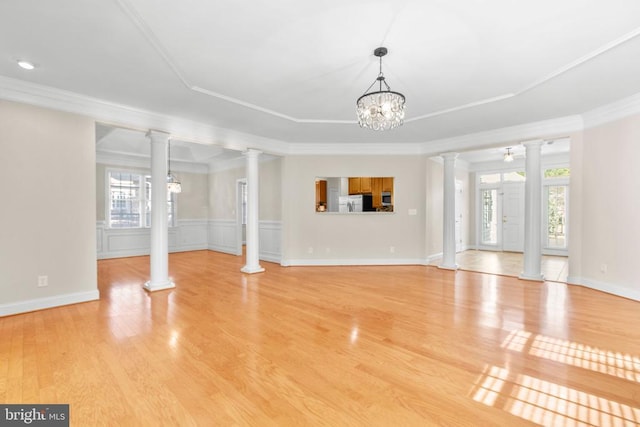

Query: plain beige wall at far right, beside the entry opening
[570,115,640,299]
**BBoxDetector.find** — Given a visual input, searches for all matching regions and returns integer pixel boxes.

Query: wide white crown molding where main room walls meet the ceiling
[6,76,640,155]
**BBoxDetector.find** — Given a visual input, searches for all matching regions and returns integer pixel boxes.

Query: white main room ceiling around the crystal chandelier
[0,0,640,152]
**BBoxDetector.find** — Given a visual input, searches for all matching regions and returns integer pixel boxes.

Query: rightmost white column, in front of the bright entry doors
[520,140,544,281]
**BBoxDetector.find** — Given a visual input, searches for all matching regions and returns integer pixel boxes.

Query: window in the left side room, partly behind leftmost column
[107,171,176,228]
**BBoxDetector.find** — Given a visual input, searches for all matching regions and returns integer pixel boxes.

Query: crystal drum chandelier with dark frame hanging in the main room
[356,47,405,130]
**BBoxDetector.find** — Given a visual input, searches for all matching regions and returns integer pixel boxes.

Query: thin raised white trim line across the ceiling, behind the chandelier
[117,0,640,125]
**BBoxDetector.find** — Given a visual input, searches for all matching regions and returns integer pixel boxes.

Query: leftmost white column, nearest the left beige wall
[144,130,175,291]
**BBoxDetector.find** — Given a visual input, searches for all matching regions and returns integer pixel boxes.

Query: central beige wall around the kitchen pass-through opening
[282,155,426,263]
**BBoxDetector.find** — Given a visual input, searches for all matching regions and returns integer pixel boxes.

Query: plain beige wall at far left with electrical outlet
[0,101,97,308]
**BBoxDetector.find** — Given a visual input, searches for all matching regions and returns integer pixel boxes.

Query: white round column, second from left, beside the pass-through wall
[240,149,264,274]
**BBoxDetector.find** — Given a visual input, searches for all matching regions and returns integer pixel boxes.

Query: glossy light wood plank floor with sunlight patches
[0,251,640,426]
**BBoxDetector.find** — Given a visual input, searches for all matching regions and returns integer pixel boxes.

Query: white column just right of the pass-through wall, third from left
[438,153,458,270]
